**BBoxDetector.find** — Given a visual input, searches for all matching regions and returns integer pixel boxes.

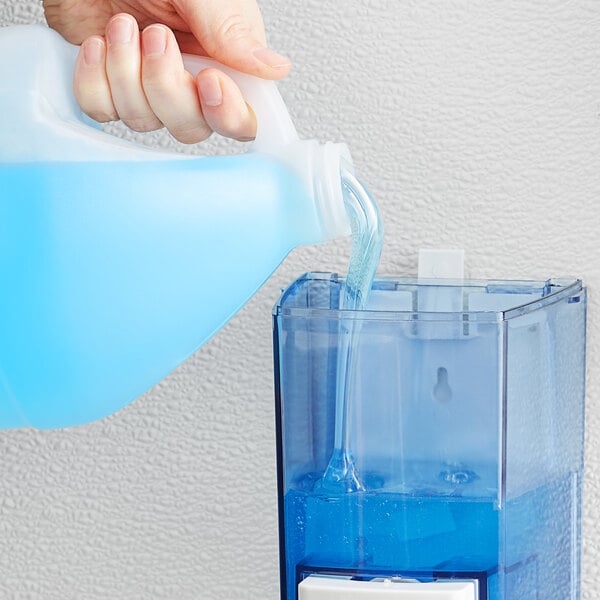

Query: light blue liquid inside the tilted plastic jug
[0,155,322,428]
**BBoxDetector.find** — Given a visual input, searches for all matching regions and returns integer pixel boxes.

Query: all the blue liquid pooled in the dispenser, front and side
[284,467,576,600]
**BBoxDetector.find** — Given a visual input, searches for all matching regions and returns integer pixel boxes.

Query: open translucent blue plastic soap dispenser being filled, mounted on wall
[274,273,586,600]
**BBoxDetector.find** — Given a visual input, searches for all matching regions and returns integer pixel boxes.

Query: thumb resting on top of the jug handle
[178,0,291,79]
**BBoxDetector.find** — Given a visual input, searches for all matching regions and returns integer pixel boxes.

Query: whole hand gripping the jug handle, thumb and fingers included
[44,0,290,143]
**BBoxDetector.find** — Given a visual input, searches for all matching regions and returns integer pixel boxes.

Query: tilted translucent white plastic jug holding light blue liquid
[0,26,350,428]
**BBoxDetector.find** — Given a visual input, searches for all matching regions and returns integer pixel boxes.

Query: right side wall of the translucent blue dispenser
[503,290,586,600]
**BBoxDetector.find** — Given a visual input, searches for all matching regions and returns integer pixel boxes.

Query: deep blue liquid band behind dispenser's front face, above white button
[286,491,499,572]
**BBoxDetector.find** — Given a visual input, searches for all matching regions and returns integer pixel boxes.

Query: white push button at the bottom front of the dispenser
[298,575,478,600]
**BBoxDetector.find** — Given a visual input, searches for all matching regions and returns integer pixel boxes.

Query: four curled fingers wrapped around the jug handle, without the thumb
[74,15,256,144]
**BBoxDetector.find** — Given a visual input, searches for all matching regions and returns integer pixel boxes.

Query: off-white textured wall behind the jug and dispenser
[0,0,600,600]
